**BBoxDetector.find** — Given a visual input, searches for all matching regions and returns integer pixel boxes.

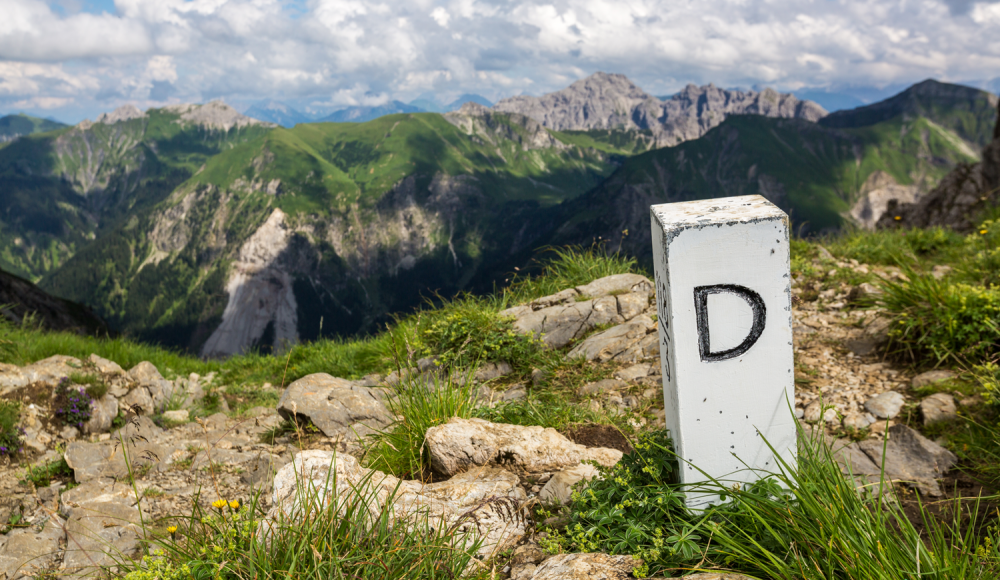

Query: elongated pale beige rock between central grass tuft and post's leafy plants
[424,417,622,477]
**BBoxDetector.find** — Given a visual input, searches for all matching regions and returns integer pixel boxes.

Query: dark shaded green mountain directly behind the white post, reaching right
[539,87,996,261]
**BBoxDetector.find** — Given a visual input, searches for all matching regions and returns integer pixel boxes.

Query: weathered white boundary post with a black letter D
[650,195,795,509]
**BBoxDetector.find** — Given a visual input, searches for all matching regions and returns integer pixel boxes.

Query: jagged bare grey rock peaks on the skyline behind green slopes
[493,72,826,147]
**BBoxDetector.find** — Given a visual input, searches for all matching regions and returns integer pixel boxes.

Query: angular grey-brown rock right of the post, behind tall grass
[858,425,958,497]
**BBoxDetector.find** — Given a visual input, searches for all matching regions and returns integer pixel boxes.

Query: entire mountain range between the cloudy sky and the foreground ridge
[0,73,996,356]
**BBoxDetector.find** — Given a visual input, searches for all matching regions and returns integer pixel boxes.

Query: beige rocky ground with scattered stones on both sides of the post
[0,259,976,580]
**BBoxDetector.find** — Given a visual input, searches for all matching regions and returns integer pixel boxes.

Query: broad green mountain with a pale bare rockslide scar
[43,106,628,356]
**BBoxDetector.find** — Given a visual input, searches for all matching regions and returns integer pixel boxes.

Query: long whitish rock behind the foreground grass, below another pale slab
[259,450,527,557]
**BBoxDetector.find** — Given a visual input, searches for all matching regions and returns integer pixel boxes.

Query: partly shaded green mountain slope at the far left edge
[0,108,269,281]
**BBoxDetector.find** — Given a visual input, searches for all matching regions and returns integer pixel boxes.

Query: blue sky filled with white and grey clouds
[0,0,1000,123]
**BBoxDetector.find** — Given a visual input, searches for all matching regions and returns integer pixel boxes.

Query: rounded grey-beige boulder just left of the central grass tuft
[278,373,392,437]
